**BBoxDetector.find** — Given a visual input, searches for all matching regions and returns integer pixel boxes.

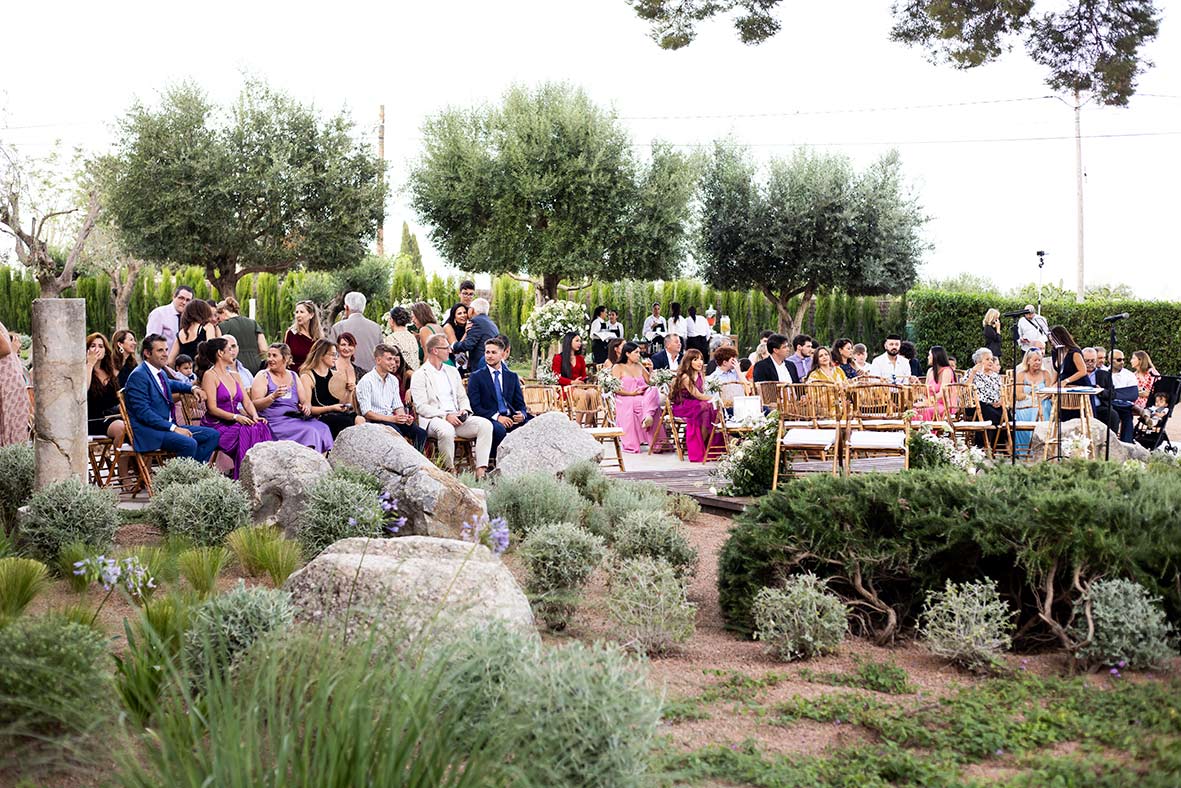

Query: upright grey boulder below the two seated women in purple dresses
[239,441,332,538]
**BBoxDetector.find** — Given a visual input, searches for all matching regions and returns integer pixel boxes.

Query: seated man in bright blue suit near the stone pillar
[123,334,221,462]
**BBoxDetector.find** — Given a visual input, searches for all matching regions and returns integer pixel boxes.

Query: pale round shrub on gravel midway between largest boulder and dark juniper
[607,556,697,655]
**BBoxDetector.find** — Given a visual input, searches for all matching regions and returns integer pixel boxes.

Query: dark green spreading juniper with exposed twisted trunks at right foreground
[718,461,1181,639]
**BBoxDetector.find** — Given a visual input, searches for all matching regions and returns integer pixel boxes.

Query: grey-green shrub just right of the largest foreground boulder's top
[520,522,606,630]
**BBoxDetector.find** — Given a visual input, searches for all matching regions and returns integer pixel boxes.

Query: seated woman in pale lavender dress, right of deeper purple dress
[250,343,332,454]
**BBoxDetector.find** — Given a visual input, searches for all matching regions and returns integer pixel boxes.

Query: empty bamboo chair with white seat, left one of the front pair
[771,383,841,489]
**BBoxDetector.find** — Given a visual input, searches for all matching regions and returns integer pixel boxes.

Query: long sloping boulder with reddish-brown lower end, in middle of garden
[331,424,488,539]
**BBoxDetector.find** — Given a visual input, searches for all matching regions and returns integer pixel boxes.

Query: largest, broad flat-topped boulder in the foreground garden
[283,536,536,638]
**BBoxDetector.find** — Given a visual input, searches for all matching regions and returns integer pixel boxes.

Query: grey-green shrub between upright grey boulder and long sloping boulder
[296,471,385,559]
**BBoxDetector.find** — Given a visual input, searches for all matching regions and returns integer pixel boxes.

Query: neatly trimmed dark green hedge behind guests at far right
[906,288,1181,375]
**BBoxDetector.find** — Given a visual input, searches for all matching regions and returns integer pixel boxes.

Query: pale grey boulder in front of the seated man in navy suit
[496,411,602,477]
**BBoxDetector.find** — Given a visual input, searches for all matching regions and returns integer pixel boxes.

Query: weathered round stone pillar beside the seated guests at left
[33,298,89,489]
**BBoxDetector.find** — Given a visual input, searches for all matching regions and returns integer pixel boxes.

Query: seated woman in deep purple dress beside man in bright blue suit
[197,337,274,478]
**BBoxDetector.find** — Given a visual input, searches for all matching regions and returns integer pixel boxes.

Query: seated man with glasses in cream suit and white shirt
[410,334,492,478]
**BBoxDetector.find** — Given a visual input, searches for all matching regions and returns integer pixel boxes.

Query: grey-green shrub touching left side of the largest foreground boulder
[184,581,293,682]
